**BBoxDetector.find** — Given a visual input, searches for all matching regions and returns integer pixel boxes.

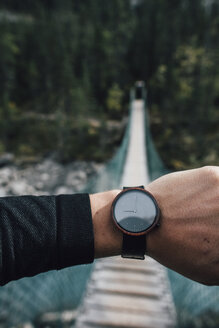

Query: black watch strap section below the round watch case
[122,233,146,260]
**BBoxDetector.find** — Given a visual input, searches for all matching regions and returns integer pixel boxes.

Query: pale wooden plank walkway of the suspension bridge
[76,100,176,328]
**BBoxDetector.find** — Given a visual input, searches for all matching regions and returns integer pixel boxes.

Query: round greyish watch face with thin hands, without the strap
[113,189,158,233]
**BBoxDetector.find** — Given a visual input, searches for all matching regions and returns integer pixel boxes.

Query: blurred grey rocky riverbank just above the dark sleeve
[0,158,103,197]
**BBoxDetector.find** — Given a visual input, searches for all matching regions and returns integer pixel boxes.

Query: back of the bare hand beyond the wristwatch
[146,166,219,285]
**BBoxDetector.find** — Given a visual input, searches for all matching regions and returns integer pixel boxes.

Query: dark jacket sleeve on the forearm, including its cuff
[0,194,94,285]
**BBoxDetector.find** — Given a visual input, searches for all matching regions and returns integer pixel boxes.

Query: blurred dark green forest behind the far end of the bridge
[0,0,219,170]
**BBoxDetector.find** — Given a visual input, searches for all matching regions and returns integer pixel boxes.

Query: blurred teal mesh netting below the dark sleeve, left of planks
[0,265,91,327]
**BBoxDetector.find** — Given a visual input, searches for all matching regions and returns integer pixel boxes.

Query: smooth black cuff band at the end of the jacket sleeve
[56,194,94,269]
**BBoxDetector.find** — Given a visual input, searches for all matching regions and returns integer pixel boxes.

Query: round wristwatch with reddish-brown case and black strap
[112,186,160,260]
